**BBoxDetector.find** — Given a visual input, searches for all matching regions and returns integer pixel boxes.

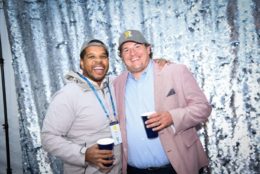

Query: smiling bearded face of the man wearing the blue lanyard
[80,46,109,85]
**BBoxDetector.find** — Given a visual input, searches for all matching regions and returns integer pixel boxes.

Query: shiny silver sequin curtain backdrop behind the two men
[4,0,260,174]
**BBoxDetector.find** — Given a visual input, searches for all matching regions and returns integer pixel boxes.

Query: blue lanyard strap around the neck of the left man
[77,72,116,118]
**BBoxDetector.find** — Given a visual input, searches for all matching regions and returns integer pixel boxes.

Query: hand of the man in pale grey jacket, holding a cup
[85,144,113,173]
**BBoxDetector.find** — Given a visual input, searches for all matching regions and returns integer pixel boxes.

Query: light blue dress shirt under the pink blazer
[125,60,170,168]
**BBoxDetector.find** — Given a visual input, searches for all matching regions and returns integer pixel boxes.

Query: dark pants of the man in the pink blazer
[127,164,177,174]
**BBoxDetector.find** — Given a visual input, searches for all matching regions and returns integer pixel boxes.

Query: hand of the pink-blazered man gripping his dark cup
[145,112,173,131]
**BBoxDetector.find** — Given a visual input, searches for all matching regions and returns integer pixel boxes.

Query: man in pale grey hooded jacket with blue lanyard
[41,39,121,174]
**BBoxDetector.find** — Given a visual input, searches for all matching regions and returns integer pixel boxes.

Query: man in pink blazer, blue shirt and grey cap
[114,30,211,174]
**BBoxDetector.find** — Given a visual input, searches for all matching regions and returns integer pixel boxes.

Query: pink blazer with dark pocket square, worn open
[114,63,211,174]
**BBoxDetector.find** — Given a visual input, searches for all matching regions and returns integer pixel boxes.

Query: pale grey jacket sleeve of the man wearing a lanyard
[41,90,86,166]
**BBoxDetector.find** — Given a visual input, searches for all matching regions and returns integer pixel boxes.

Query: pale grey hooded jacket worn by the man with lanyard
[41,72,121,174]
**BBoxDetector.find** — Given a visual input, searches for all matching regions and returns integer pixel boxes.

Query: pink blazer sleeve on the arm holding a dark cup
[169,66,211,133]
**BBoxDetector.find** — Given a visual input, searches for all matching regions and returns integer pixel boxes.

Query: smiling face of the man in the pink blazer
[120,42,151,78]
